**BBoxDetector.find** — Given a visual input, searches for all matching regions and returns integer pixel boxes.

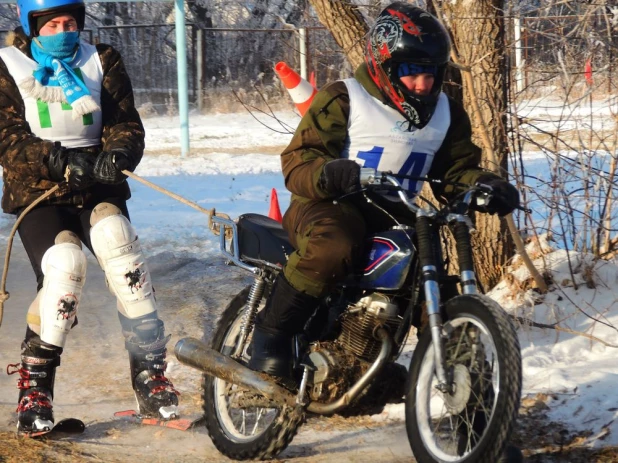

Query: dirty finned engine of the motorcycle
[309,293,402,403]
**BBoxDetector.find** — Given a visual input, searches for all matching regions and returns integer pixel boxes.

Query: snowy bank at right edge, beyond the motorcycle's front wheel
[489,232,618,448]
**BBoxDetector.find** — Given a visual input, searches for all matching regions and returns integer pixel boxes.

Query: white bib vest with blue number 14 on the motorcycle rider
[341,79,451,198]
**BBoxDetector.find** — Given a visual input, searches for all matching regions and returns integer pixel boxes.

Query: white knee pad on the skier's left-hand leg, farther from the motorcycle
[33,231,87,347]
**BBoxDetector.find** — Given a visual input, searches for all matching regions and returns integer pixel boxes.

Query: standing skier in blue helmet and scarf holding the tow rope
[0,0,178,433]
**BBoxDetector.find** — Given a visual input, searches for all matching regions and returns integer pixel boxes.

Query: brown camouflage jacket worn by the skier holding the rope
[0,28,144,213]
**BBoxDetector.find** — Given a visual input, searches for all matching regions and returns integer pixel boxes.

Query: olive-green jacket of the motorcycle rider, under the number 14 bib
[281,64,500,202]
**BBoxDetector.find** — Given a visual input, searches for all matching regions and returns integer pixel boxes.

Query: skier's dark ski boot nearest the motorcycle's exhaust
[125,319,180,420]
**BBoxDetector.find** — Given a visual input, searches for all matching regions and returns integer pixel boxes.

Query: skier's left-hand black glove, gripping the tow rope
[47,144,95,190]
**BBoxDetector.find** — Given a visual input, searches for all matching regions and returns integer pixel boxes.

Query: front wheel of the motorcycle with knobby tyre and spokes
[405,295,522,463]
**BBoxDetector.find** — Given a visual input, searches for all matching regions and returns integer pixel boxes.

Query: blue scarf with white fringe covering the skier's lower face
[30,32,100,119]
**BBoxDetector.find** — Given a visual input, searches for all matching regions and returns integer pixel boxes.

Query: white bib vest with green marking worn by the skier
[0,42,103,148]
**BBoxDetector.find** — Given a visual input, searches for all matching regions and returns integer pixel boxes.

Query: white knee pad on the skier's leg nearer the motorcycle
[90,203,157,318]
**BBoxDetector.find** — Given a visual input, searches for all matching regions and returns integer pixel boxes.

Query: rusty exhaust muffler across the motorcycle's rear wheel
[174,338,297,407]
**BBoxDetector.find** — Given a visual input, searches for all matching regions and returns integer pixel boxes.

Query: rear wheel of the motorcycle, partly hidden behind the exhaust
[202,287,304,460]
